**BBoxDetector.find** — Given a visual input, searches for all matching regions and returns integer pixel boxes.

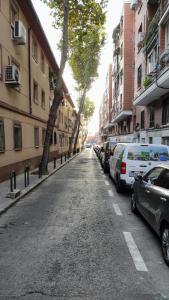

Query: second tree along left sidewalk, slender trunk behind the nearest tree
[69,20,105,153]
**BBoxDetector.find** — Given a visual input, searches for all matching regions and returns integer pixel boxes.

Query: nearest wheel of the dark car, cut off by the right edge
[161,225,169,266]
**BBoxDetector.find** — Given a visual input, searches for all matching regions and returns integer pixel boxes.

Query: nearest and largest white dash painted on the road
[123,232,148,272]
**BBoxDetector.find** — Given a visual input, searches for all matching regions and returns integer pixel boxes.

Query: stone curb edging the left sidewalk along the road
[0,152,80,216]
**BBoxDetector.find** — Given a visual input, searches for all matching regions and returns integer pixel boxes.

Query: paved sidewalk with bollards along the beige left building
[0,154,77,215]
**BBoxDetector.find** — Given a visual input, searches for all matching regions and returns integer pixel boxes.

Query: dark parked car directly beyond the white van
[101,141,117,173]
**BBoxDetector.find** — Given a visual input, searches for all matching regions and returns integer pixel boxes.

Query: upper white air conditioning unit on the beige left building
[13,21,26,45]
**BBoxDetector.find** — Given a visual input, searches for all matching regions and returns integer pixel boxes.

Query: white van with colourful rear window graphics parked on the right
[109,143,169,192]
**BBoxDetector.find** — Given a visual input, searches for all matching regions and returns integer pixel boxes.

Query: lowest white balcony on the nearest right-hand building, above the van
[133,68,169,106]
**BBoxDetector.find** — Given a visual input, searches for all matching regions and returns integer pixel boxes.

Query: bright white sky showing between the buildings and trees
[32,0,124,134]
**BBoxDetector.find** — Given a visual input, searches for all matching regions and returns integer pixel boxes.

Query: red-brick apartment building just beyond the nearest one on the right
[111,1,134,142]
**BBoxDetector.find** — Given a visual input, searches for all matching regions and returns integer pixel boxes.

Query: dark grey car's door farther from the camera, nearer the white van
[137,167,163,225]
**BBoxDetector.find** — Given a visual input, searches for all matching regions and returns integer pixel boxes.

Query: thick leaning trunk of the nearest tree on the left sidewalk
[39,0,69,174]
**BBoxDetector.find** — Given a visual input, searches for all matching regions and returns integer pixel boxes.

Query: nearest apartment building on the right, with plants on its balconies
[131,0,169,145]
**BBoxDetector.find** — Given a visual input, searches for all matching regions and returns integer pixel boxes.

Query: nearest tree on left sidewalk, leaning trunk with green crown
[40,0,107,174]
